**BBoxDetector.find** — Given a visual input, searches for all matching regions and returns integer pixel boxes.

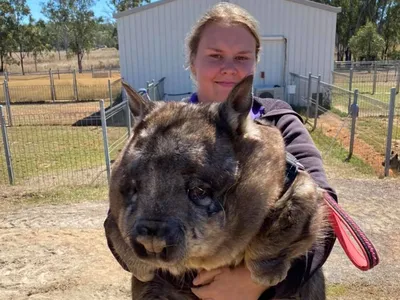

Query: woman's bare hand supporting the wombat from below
[192,265,267,300]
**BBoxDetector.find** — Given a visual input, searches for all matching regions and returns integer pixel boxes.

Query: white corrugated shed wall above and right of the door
[231,0,336,82]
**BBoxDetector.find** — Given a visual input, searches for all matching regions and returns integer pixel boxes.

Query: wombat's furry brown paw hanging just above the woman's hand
[248,259,290,287]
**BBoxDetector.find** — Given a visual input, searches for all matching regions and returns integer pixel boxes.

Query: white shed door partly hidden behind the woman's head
[254,37,286,86]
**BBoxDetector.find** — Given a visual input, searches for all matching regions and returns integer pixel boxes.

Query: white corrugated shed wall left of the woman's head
[118,0,219,97]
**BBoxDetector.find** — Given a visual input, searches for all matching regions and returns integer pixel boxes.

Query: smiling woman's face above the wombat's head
[191,24,256,102]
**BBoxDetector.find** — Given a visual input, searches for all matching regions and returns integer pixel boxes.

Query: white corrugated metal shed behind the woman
[114,0,341,99]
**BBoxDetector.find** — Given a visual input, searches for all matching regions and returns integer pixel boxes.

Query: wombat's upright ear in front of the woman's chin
[221,75,253,131]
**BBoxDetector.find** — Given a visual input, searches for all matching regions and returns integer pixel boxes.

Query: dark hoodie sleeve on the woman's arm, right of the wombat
[255,98,338,299]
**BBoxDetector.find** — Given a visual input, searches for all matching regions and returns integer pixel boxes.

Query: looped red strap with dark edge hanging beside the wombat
[324,192,379,271]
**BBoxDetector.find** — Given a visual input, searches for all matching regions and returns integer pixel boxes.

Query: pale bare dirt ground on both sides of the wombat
[0,178,400,300]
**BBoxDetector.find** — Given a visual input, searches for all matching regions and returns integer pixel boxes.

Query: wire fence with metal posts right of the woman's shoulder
[291,73,400,175]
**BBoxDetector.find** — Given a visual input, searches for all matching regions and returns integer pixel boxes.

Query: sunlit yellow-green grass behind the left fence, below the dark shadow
[0,126,127,186]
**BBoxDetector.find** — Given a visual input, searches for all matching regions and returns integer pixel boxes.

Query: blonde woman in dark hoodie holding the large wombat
[185,3,337,300]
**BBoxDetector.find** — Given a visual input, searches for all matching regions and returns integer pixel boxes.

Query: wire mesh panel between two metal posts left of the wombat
[0,102,112,187]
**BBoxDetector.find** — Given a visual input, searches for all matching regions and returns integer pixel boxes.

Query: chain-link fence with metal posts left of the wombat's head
[0,99,130,188]
